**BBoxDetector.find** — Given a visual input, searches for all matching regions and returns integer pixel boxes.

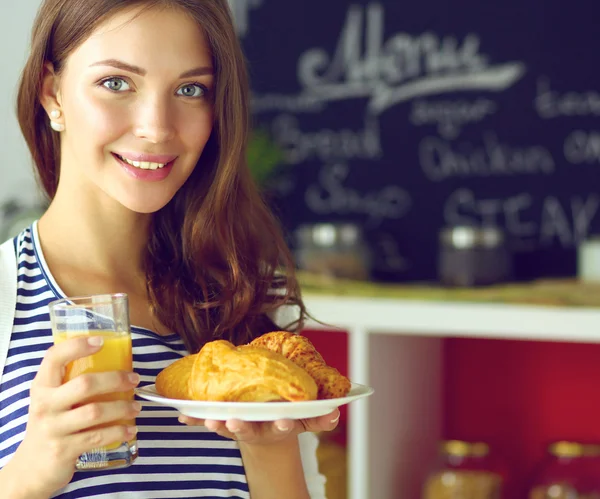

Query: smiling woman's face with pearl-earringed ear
[45,4,214,213]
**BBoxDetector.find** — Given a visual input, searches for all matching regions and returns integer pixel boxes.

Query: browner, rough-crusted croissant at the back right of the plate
[249,331,351,399]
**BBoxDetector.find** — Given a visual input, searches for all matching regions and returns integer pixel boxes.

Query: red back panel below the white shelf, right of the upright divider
[444,339,600,498]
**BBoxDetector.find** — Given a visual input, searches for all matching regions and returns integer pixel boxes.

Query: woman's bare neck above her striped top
[38,179,151,281]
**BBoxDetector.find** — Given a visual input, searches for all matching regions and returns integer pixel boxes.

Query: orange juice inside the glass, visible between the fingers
[54,331,135,425]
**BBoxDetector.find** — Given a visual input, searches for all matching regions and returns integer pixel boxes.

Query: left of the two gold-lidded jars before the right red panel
[421,440,506,499]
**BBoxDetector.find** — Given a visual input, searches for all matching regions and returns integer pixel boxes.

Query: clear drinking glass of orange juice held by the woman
[49,293,138,470]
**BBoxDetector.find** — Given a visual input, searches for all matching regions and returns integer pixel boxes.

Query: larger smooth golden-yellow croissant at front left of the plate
[156,340,317,402]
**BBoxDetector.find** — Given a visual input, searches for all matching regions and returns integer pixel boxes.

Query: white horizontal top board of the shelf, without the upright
[305,295,600,343]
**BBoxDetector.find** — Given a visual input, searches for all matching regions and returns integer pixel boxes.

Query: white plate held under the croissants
[135,383,374,421]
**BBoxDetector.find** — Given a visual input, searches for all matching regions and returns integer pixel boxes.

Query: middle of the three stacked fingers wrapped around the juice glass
[56,400,142,435]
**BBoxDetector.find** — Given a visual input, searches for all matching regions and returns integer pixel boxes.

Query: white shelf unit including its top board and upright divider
[304,294,600,499]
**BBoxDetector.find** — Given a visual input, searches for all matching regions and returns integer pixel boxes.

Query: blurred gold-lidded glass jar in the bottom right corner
[528,441,600,499]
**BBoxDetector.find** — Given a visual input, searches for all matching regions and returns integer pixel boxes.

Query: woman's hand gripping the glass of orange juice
[7,337,140,497]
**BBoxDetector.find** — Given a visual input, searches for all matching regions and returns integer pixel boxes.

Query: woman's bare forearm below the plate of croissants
[240,438,310,499]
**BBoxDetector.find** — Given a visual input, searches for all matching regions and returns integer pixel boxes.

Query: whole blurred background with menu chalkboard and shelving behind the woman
[0,0,600,499]
